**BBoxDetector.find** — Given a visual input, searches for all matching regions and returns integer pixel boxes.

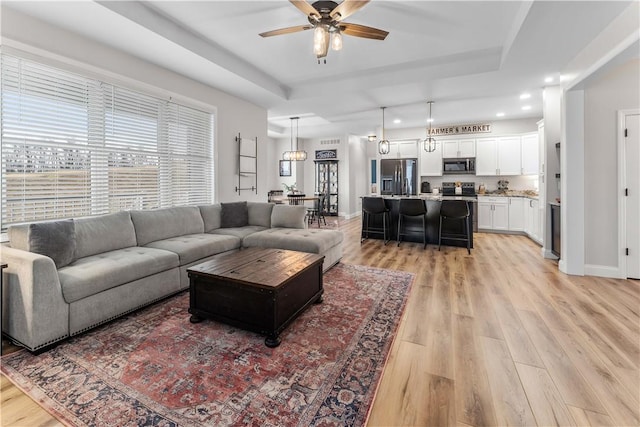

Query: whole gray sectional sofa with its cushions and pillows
[1,202,343,351]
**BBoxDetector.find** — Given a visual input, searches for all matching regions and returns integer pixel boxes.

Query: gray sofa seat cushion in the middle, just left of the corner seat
[146,233,241,265]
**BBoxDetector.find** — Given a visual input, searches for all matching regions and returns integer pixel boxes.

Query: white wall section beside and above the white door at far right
[584,59,640,268]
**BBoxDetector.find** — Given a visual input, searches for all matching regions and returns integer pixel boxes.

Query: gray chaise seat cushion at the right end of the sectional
[242,229,343,254]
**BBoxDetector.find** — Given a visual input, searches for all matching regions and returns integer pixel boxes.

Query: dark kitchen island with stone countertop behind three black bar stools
[363,194,477,248]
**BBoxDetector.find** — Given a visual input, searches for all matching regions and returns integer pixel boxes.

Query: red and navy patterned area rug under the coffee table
[2,264,413,426]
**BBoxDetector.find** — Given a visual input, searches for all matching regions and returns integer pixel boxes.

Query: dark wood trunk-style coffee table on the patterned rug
[187,248,324,347]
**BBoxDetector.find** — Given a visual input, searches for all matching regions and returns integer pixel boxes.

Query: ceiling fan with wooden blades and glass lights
[260,0,389,64]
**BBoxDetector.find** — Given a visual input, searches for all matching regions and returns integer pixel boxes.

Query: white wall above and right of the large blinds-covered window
[1,8,268,202]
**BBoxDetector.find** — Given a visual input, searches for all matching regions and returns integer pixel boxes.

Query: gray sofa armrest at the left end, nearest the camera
[0,246,69,351]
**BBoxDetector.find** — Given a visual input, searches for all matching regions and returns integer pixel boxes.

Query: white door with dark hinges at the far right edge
[618,110,640,279]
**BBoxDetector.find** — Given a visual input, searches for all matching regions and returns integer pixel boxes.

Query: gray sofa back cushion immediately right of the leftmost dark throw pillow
[75,211,136,258]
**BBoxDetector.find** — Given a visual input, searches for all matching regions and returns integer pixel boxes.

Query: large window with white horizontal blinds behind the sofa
[0,54,213,231]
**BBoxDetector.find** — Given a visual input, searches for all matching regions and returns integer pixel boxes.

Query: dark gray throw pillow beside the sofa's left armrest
[29,219,76,268]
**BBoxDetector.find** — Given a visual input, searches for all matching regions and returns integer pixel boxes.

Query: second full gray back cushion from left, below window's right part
[131,206,204,246]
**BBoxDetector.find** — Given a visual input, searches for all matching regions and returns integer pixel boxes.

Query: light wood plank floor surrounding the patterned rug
[0,219,640,426]
